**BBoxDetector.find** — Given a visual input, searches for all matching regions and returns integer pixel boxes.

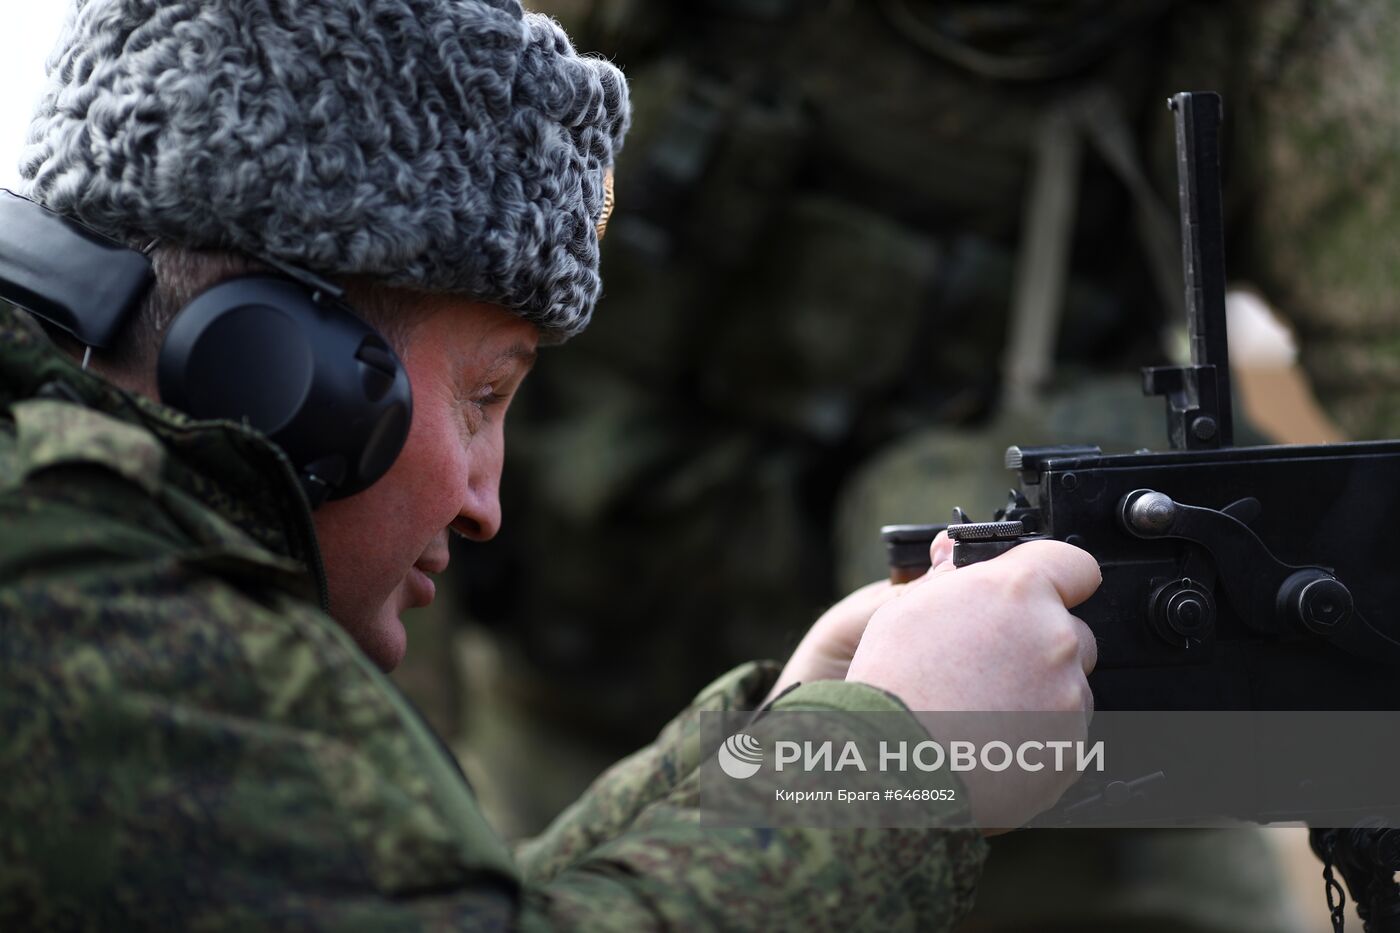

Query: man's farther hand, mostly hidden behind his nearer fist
[763,534,953,706]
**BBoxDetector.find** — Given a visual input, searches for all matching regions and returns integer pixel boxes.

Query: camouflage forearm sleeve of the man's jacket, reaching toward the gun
[517,664,986,930]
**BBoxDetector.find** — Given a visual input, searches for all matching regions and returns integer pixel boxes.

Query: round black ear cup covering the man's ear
[157,276,413,507]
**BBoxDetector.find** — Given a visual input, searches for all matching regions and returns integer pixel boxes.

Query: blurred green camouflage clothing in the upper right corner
[1232,0,1400,440]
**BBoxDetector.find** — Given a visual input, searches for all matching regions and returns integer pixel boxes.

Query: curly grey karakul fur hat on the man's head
[21,0,629,342]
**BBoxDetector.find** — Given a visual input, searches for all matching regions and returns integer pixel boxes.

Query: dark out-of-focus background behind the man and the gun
[0,0,1400,930]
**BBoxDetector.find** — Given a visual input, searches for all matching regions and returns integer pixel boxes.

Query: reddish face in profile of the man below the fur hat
[315,296,539,671]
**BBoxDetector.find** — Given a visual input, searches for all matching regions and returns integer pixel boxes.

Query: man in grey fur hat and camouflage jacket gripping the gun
[0,0,1098,929]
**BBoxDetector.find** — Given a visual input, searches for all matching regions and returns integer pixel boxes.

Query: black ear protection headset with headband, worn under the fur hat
[0,188,413,509]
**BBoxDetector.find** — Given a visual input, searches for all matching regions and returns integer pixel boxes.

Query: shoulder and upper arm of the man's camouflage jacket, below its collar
[0,411,514,927]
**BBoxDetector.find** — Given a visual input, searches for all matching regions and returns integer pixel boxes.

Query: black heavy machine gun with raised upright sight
[882,94,1400,930]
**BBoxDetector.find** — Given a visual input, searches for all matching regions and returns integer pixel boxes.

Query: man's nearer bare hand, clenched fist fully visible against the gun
[846,541,1102,825]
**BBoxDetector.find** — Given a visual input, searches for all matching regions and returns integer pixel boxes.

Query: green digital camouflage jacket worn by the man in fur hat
[0,305,986,930]
